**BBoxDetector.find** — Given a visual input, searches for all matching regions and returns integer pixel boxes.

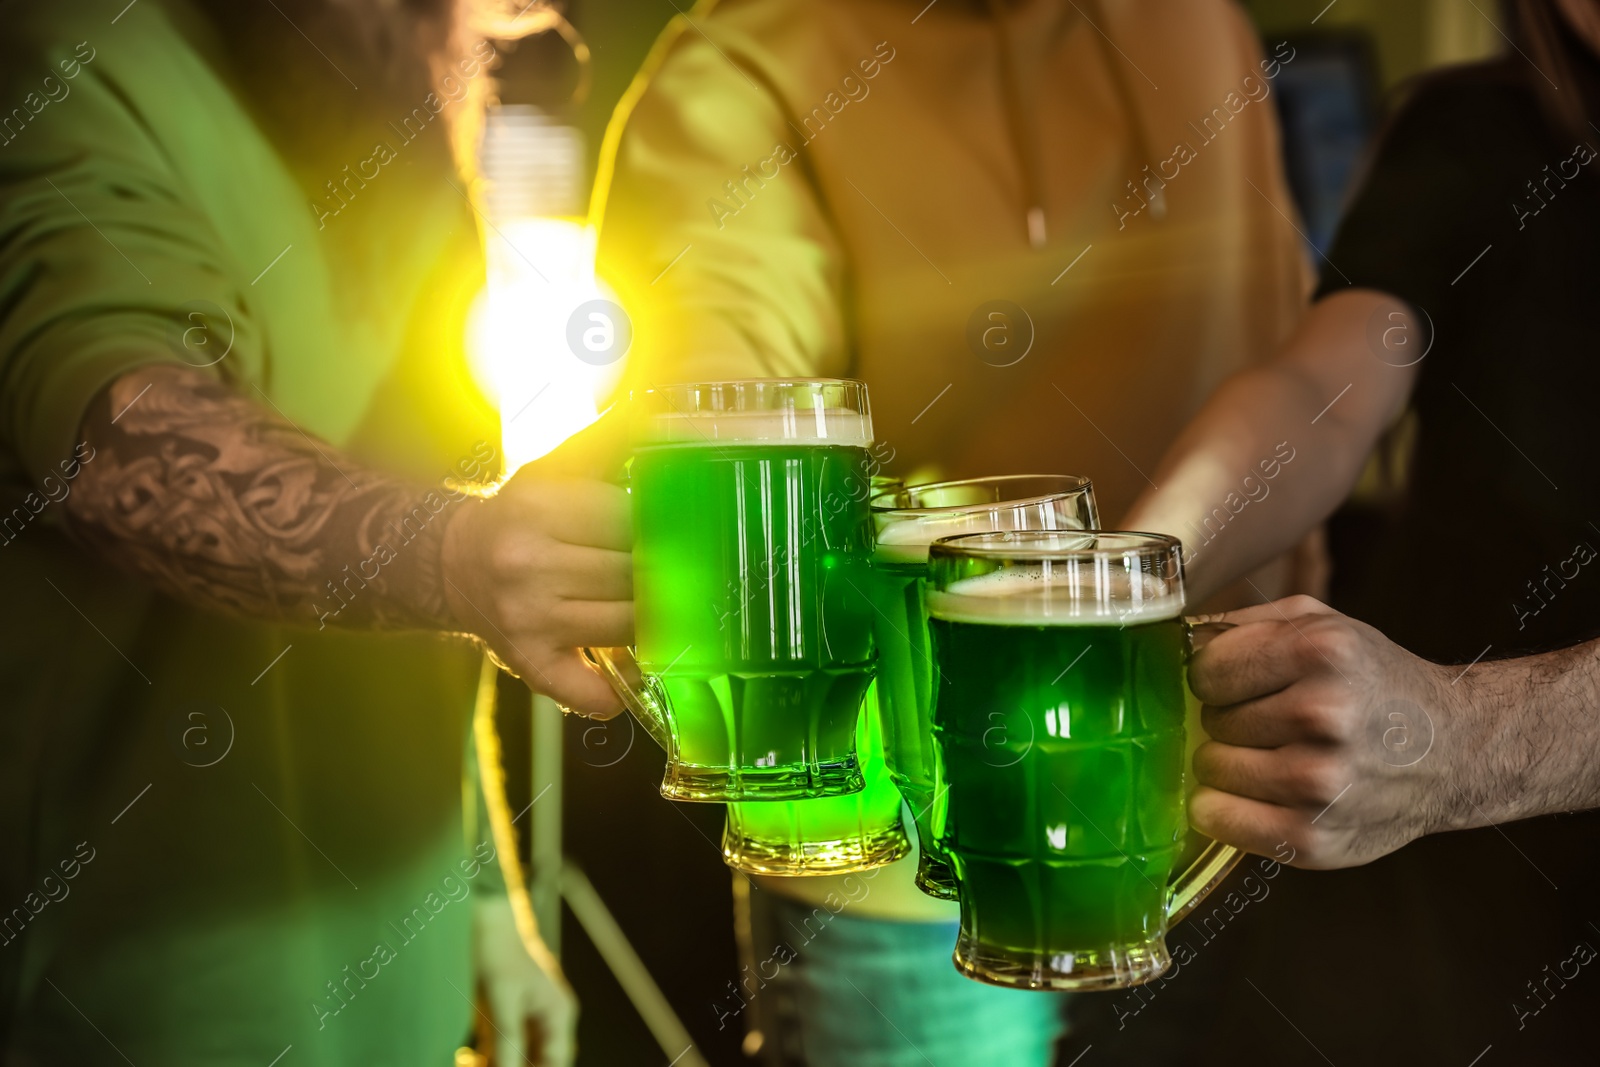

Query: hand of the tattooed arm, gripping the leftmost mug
[443,419,634,718]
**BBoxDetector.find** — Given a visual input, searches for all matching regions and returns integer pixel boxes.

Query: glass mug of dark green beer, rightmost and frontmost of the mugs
[928,531,1238,990]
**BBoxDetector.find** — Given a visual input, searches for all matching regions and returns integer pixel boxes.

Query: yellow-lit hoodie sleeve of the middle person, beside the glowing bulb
[595,18,850,390]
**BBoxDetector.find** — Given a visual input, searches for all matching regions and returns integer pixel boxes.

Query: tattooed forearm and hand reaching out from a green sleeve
[66,365,632,713]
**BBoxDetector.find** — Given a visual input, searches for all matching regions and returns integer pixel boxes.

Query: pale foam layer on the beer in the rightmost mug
[928,558,1184,625]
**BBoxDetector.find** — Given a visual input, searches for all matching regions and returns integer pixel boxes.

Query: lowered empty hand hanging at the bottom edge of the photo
[472,894,578,1067]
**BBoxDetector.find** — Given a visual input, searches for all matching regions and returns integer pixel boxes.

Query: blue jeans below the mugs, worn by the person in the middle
[749,886,1064,1067]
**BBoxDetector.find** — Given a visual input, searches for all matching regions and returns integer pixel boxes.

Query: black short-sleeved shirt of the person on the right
[1069,56,1600,1067]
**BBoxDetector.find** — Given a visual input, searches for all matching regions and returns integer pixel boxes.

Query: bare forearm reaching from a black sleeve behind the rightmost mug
[1122,290,1424,603]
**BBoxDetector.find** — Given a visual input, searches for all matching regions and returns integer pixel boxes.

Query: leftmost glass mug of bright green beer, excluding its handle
[629,381,874,800]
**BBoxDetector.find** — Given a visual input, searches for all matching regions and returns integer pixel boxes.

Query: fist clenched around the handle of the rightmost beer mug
[1189,597,1483,869]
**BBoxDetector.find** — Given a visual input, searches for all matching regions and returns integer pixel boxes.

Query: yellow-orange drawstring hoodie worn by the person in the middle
[595,0,1307,522]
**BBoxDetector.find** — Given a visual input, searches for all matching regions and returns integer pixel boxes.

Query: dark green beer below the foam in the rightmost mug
[933,619,1184,955]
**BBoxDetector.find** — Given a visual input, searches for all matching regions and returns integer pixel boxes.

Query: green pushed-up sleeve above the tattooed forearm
[0,21,259,480]
